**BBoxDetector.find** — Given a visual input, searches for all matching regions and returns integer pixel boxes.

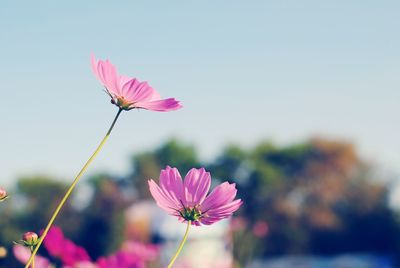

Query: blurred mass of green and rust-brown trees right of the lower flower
[210,138,399,261]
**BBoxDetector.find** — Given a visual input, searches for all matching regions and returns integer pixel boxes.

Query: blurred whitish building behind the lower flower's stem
[125,201,233,268]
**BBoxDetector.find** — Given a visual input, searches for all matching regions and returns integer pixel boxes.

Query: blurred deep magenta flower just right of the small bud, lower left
[43,227,90,265]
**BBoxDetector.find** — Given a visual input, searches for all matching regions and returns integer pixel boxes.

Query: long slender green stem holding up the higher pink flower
[25,108,123,268]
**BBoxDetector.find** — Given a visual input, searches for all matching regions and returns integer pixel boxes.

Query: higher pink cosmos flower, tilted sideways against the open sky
[91,55,182,112]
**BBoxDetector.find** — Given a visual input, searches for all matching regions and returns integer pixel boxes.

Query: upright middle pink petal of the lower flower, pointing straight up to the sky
[183,168,211,207]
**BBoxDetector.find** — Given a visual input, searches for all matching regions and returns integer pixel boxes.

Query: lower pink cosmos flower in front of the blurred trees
[148,166,243,226]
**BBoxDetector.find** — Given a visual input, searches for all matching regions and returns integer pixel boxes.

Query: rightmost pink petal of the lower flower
[201,182,237,212]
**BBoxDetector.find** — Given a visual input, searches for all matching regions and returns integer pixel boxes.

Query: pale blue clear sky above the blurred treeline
[0,0,400,185]
